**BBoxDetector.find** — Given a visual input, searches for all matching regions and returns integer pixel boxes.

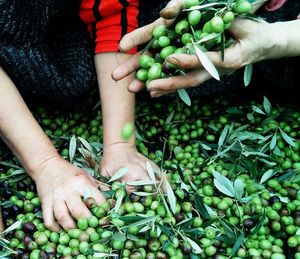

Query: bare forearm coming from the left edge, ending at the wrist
[0,68,58,178]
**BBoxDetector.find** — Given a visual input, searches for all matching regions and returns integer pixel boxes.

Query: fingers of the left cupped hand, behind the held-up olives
[112,0,184,92]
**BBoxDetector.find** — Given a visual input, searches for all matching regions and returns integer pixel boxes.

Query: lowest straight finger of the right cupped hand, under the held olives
[149,69,211,92]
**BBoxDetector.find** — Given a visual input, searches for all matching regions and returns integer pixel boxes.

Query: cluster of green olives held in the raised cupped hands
[136,0,252,85]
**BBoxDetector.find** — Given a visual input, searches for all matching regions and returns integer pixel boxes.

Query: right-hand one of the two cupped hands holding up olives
[113,16,285,97]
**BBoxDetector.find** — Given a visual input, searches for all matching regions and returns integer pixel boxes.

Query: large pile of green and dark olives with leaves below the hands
[0,94,300,259]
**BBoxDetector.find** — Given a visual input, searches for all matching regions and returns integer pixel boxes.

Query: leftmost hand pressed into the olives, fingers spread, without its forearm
[34,157,105,231]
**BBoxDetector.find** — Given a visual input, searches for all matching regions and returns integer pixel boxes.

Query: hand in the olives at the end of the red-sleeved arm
[100,143,158,192]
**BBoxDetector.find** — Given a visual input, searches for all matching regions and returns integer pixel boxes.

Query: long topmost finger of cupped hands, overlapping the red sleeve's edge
[119,18,172,53]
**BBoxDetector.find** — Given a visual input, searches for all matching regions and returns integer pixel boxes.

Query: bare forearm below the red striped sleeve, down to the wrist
[95,53,135,147]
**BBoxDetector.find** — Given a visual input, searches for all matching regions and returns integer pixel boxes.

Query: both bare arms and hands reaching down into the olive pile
[0,53,156,231]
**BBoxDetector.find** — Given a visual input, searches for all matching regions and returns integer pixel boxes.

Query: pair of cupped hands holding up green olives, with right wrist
[112,0,300,97]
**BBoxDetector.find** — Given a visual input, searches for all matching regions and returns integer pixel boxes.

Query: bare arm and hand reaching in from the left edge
[0,67,104,230]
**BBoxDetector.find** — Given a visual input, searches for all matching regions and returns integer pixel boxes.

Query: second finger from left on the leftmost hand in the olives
[53,201,76,230]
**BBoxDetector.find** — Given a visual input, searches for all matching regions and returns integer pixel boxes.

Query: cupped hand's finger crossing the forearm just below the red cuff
[111,53,141,81]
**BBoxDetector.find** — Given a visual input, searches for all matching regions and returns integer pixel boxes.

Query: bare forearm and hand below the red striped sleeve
[95,53,155,187]
